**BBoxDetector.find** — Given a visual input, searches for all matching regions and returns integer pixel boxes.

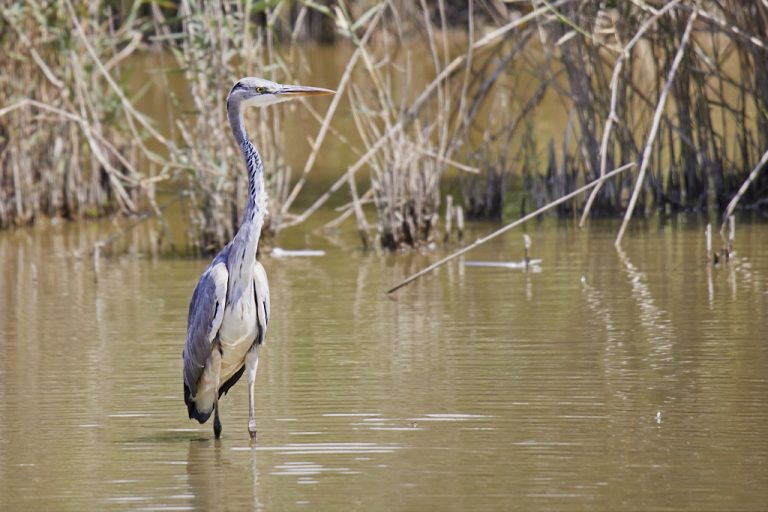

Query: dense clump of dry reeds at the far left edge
[0,1,153,228]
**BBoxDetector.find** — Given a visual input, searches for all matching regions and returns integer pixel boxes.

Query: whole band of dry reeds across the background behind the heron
[0,0,768,252]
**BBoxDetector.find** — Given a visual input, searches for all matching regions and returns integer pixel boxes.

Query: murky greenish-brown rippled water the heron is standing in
[0,218,768,510]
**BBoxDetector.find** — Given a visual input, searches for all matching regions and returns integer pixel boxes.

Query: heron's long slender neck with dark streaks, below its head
[227,98,267,282]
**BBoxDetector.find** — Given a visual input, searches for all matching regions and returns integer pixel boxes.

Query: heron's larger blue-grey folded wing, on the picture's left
[184,258,229,396]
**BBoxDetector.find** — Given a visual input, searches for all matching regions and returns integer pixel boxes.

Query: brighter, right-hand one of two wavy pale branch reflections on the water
[616,249,674,361]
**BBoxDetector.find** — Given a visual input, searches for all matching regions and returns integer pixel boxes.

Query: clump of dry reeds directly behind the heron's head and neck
[158,0,312,254]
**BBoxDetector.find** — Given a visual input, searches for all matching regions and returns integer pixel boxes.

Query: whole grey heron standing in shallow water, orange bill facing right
[183,77,334,439]
